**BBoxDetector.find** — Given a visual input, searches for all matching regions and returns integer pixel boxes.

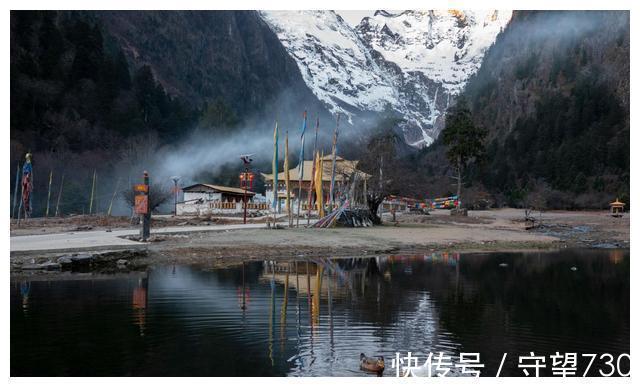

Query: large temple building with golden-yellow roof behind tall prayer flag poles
[262,155,370,212]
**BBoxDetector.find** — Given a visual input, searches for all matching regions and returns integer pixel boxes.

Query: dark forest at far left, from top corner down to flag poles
[10,11,238,216]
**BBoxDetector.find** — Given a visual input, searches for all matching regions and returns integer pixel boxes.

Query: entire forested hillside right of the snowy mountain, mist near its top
[422,11,630,208]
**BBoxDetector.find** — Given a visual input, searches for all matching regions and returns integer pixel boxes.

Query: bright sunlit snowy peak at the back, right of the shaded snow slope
[357,10,511,93]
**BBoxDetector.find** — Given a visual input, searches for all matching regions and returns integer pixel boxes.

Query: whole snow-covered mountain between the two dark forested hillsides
[260,10,511,147]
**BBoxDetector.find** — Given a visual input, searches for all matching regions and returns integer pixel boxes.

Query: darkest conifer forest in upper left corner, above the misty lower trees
[11,11,200,156]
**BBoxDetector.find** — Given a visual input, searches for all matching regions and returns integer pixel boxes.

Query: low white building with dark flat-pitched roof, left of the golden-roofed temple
[176,183,267,216]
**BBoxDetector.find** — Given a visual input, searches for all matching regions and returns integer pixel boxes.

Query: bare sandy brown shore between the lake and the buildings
[11,209,630,272]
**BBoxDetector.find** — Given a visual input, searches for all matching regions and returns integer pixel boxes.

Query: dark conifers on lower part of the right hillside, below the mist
[476,64,630,207]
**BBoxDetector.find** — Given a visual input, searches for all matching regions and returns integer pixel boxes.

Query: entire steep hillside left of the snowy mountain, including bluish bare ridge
[10,11,326,215]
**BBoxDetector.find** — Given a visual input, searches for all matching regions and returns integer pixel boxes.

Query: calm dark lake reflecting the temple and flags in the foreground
[10,250,630,377]
